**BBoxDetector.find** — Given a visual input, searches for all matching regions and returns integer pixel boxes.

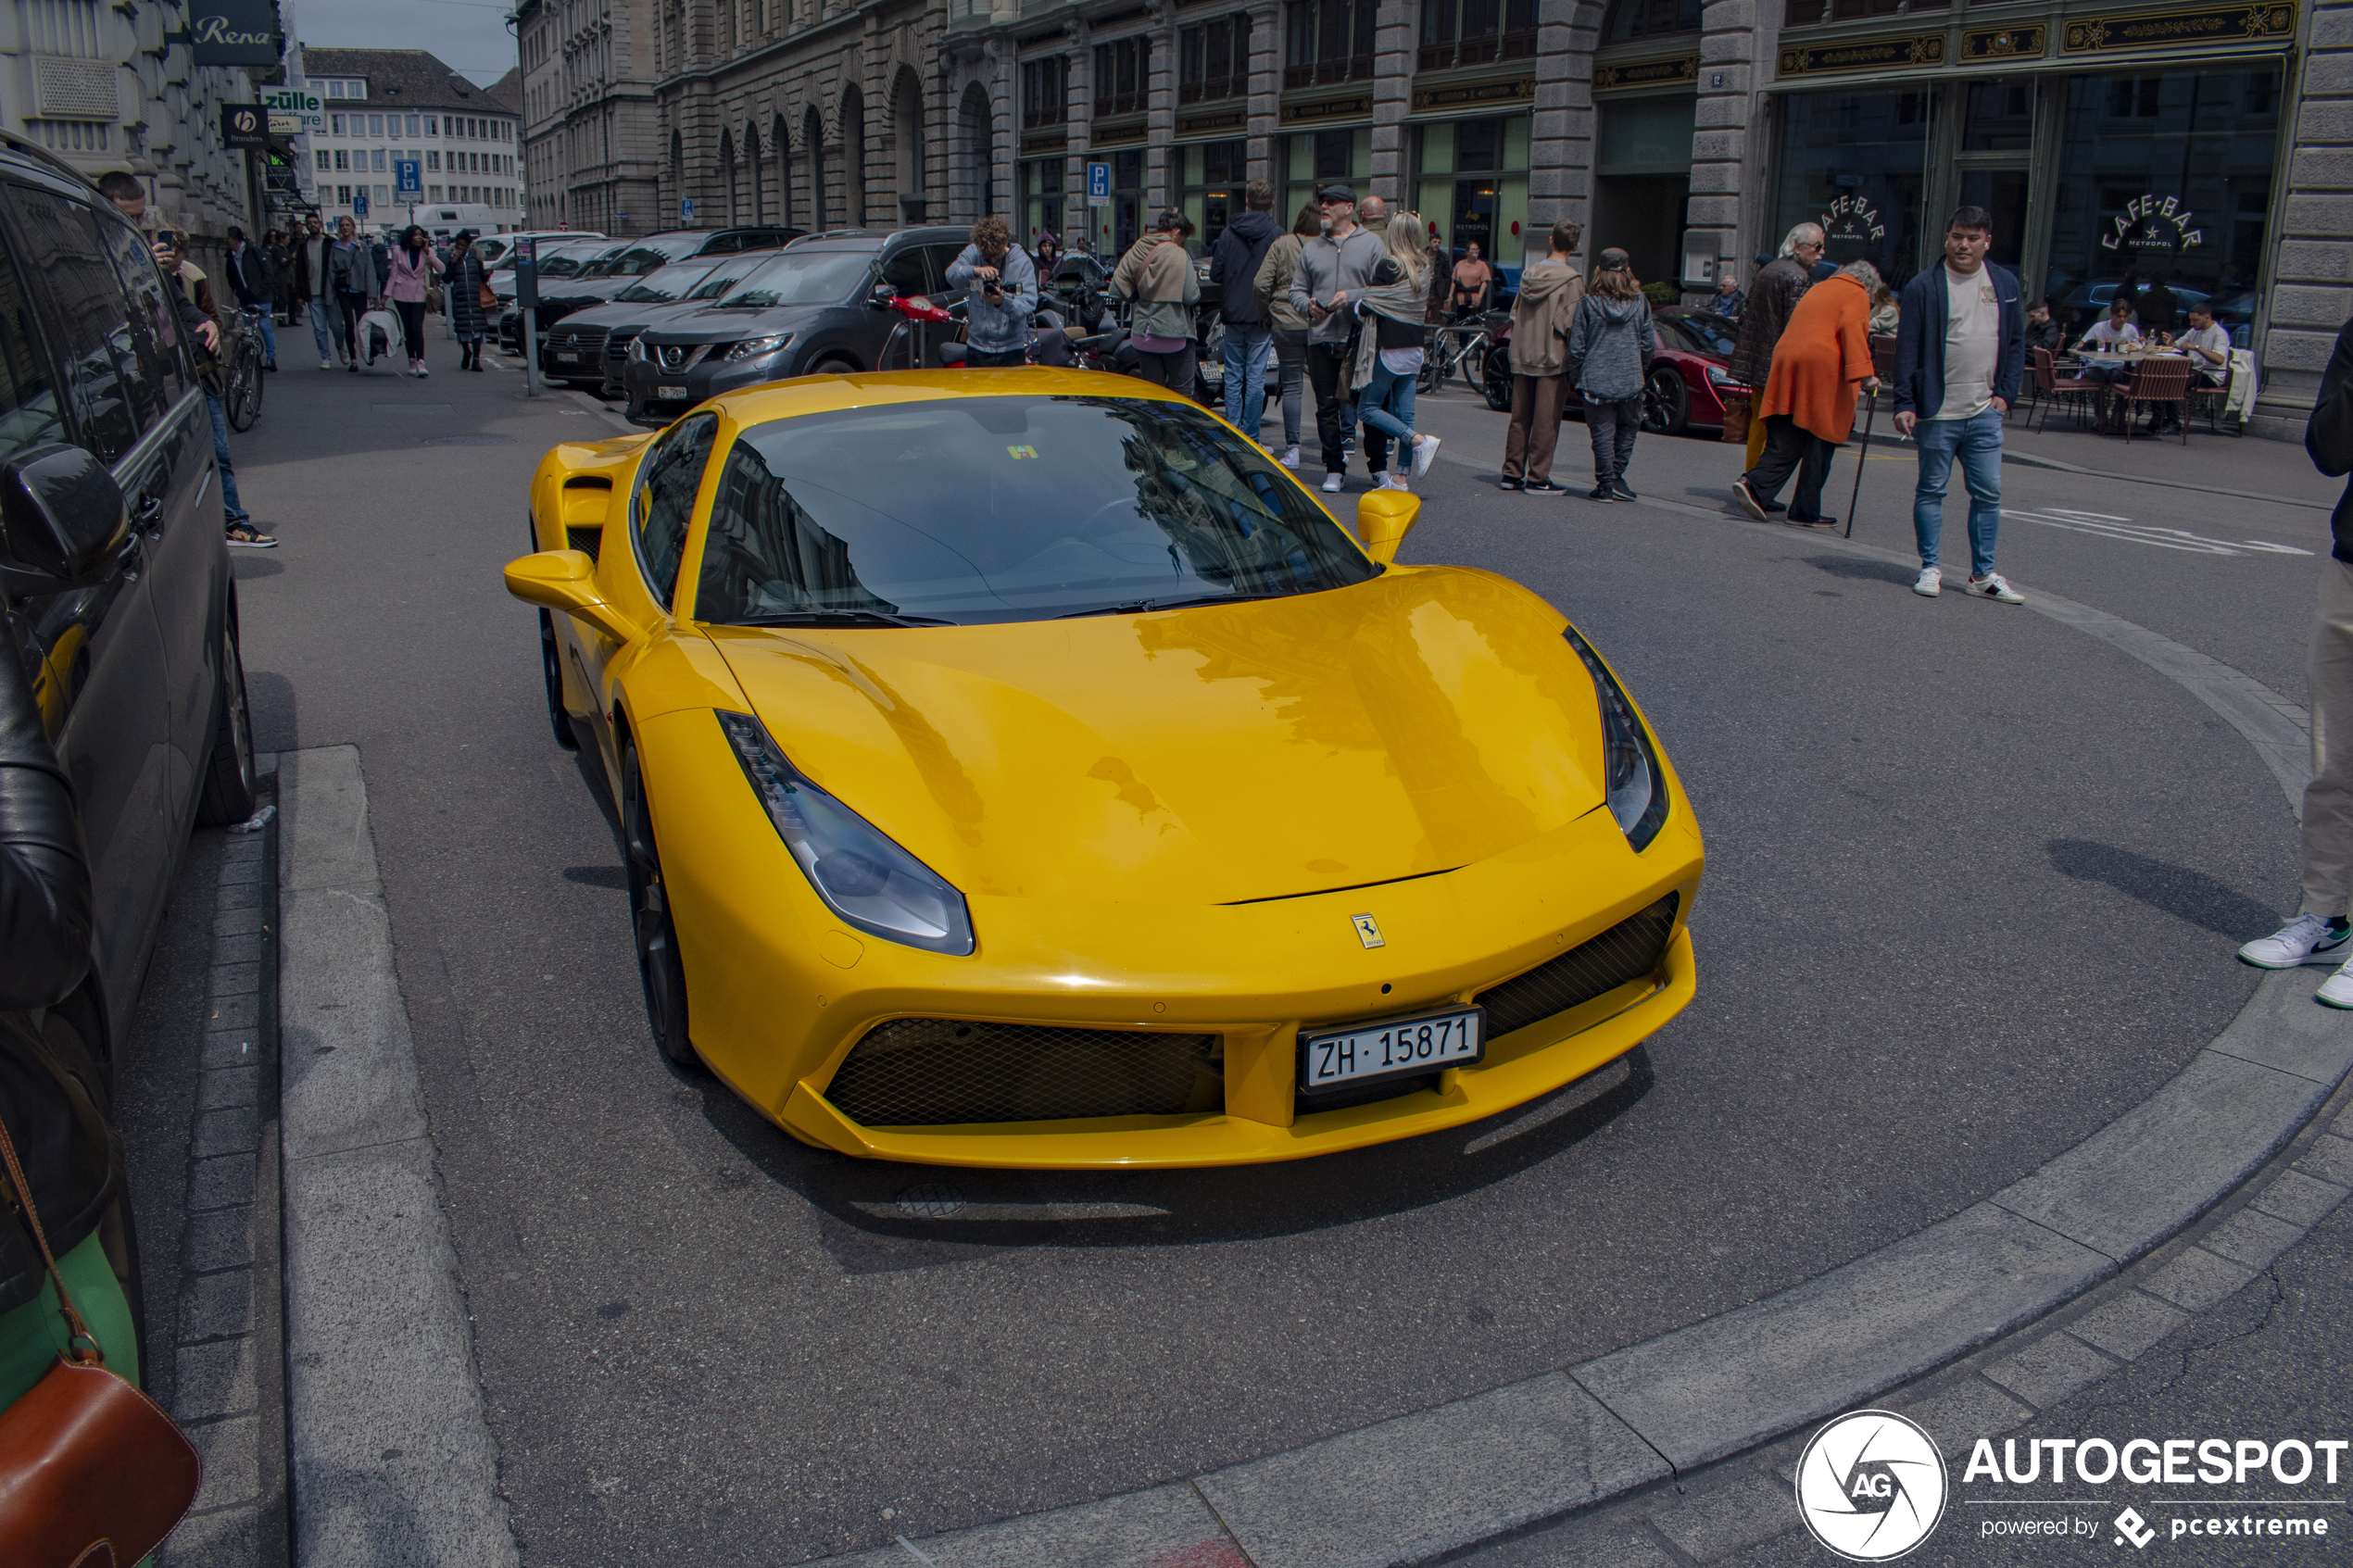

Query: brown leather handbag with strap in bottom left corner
[0,1126,205,1568]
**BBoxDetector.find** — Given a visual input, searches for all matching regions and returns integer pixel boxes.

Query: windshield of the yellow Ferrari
[694,397,1378,625]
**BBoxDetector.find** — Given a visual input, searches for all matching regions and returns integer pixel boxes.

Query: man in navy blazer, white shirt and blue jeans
[1894,207,2026,604]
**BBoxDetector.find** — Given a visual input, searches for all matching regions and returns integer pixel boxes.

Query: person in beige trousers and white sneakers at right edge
[2238,322,2353,1009]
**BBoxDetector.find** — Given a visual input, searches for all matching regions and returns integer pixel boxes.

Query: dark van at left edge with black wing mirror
[0,141,254,1077]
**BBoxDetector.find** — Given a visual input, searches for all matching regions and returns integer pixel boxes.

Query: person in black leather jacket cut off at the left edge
[0,639,139,1406]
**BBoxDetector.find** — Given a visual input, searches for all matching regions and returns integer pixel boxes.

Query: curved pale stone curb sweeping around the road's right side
[831,479,2353,1568]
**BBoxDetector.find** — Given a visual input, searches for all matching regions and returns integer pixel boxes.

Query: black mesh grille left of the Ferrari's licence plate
[826,1018,1224,1126]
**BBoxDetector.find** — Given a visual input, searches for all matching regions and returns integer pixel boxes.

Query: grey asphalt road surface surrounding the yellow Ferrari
[224,341,2325,1568]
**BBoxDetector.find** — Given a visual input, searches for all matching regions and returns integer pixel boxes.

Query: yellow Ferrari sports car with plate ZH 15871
[506,370,1704,1166]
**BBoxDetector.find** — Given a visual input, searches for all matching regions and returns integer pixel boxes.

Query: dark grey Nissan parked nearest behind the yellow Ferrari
[623,228,972,423]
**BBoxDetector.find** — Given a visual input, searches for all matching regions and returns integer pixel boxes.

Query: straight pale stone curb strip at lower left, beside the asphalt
[278,746,515,1568]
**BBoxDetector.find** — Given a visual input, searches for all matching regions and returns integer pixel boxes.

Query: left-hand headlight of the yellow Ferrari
[720,712,972,957]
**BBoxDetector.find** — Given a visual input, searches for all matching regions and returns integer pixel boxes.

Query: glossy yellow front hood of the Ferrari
[709,567,1603,905]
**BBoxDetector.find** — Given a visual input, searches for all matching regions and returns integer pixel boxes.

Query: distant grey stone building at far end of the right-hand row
[515,0,675,237]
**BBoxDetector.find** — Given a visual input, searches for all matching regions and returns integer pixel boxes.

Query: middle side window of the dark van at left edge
[12,186,142,463]
